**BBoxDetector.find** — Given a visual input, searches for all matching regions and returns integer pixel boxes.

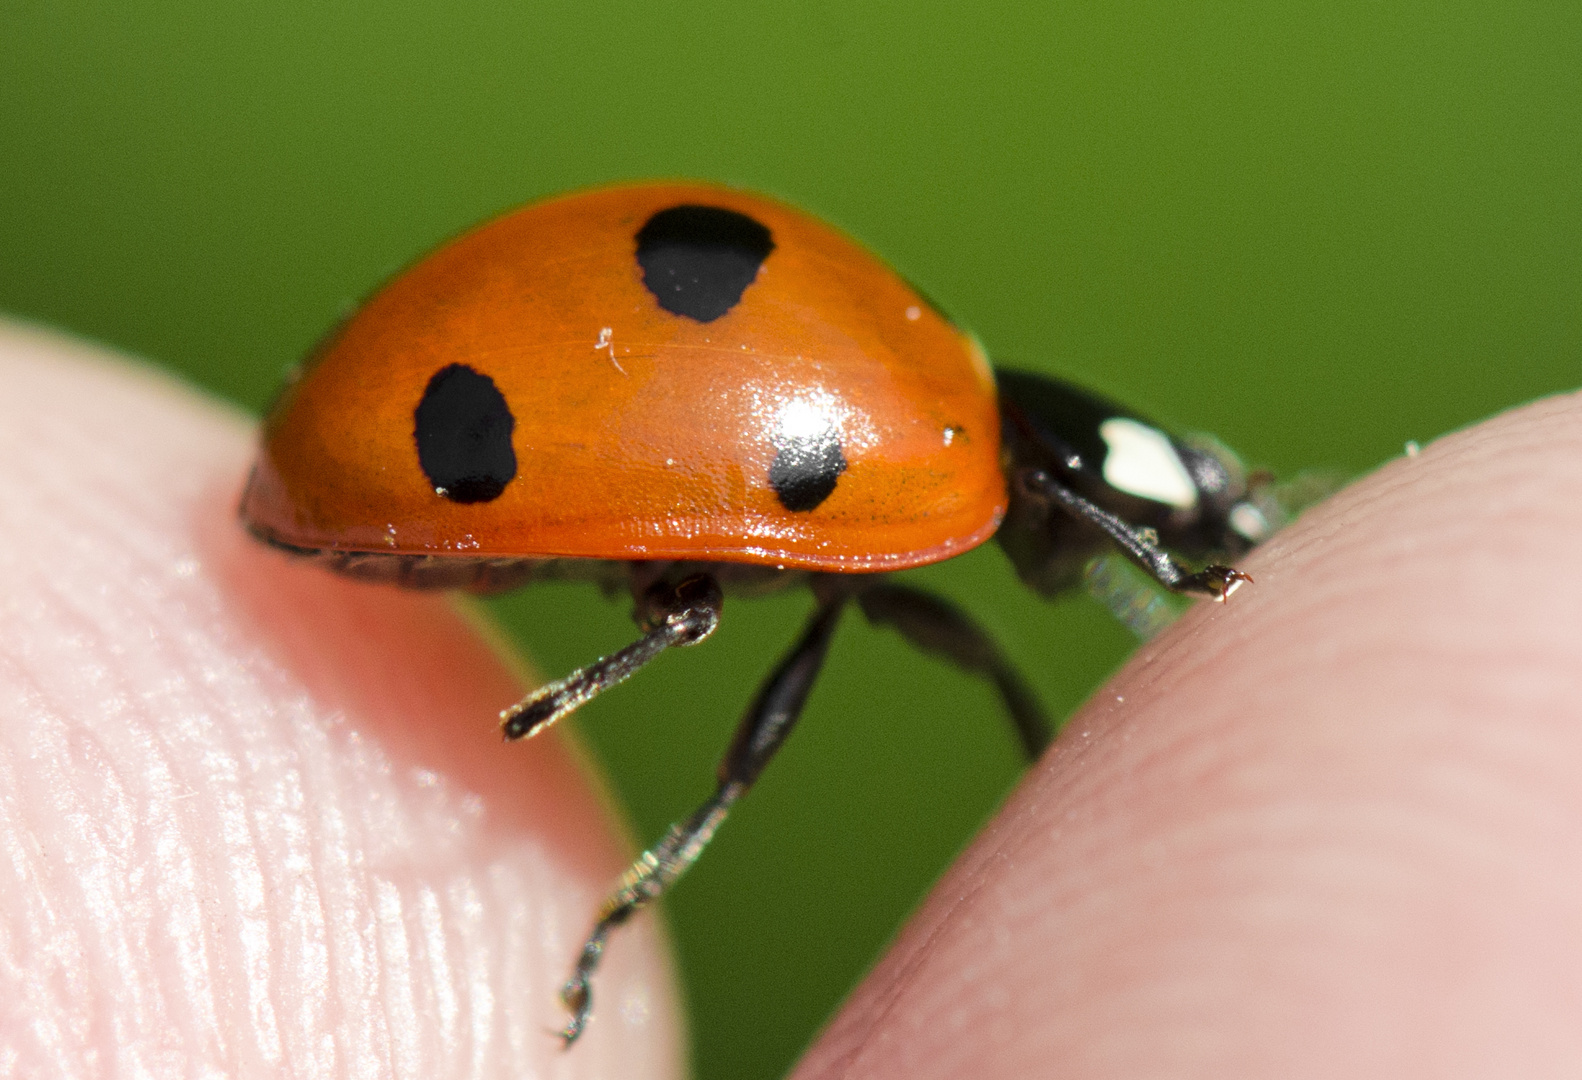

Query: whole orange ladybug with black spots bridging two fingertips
[240,183,1269,1045]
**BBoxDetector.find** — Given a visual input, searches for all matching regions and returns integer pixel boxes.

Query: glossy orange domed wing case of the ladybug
[244,185,1006,571]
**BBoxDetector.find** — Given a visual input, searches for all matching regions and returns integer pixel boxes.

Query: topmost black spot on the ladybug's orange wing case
[638,206,775,323]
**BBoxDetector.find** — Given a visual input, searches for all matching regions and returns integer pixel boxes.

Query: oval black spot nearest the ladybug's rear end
[413,364,516,503]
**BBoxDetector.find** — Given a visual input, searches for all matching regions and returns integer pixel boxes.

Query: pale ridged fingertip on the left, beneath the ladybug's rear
[0,326,683,1080]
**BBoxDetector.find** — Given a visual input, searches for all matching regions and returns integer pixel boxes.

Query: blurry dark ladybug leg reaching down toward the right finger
[857,582,1054,761]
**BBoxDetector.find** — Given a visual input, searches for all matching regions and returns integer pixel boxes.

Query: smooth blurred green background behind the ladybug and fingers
[0,0,1582,1080]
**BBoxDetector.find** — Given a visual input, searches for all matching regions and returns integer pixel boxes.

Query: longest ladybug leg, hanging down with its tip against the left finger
[560,596,845,1047]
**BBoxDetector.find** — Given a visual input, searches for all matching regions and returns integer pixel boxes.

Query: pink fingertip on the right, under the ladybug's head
[794,385,1582,1080]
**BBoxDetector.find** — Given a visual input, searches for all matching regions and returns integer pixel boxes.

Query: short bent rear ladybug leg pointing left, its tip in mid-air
[500,574,725,738]
